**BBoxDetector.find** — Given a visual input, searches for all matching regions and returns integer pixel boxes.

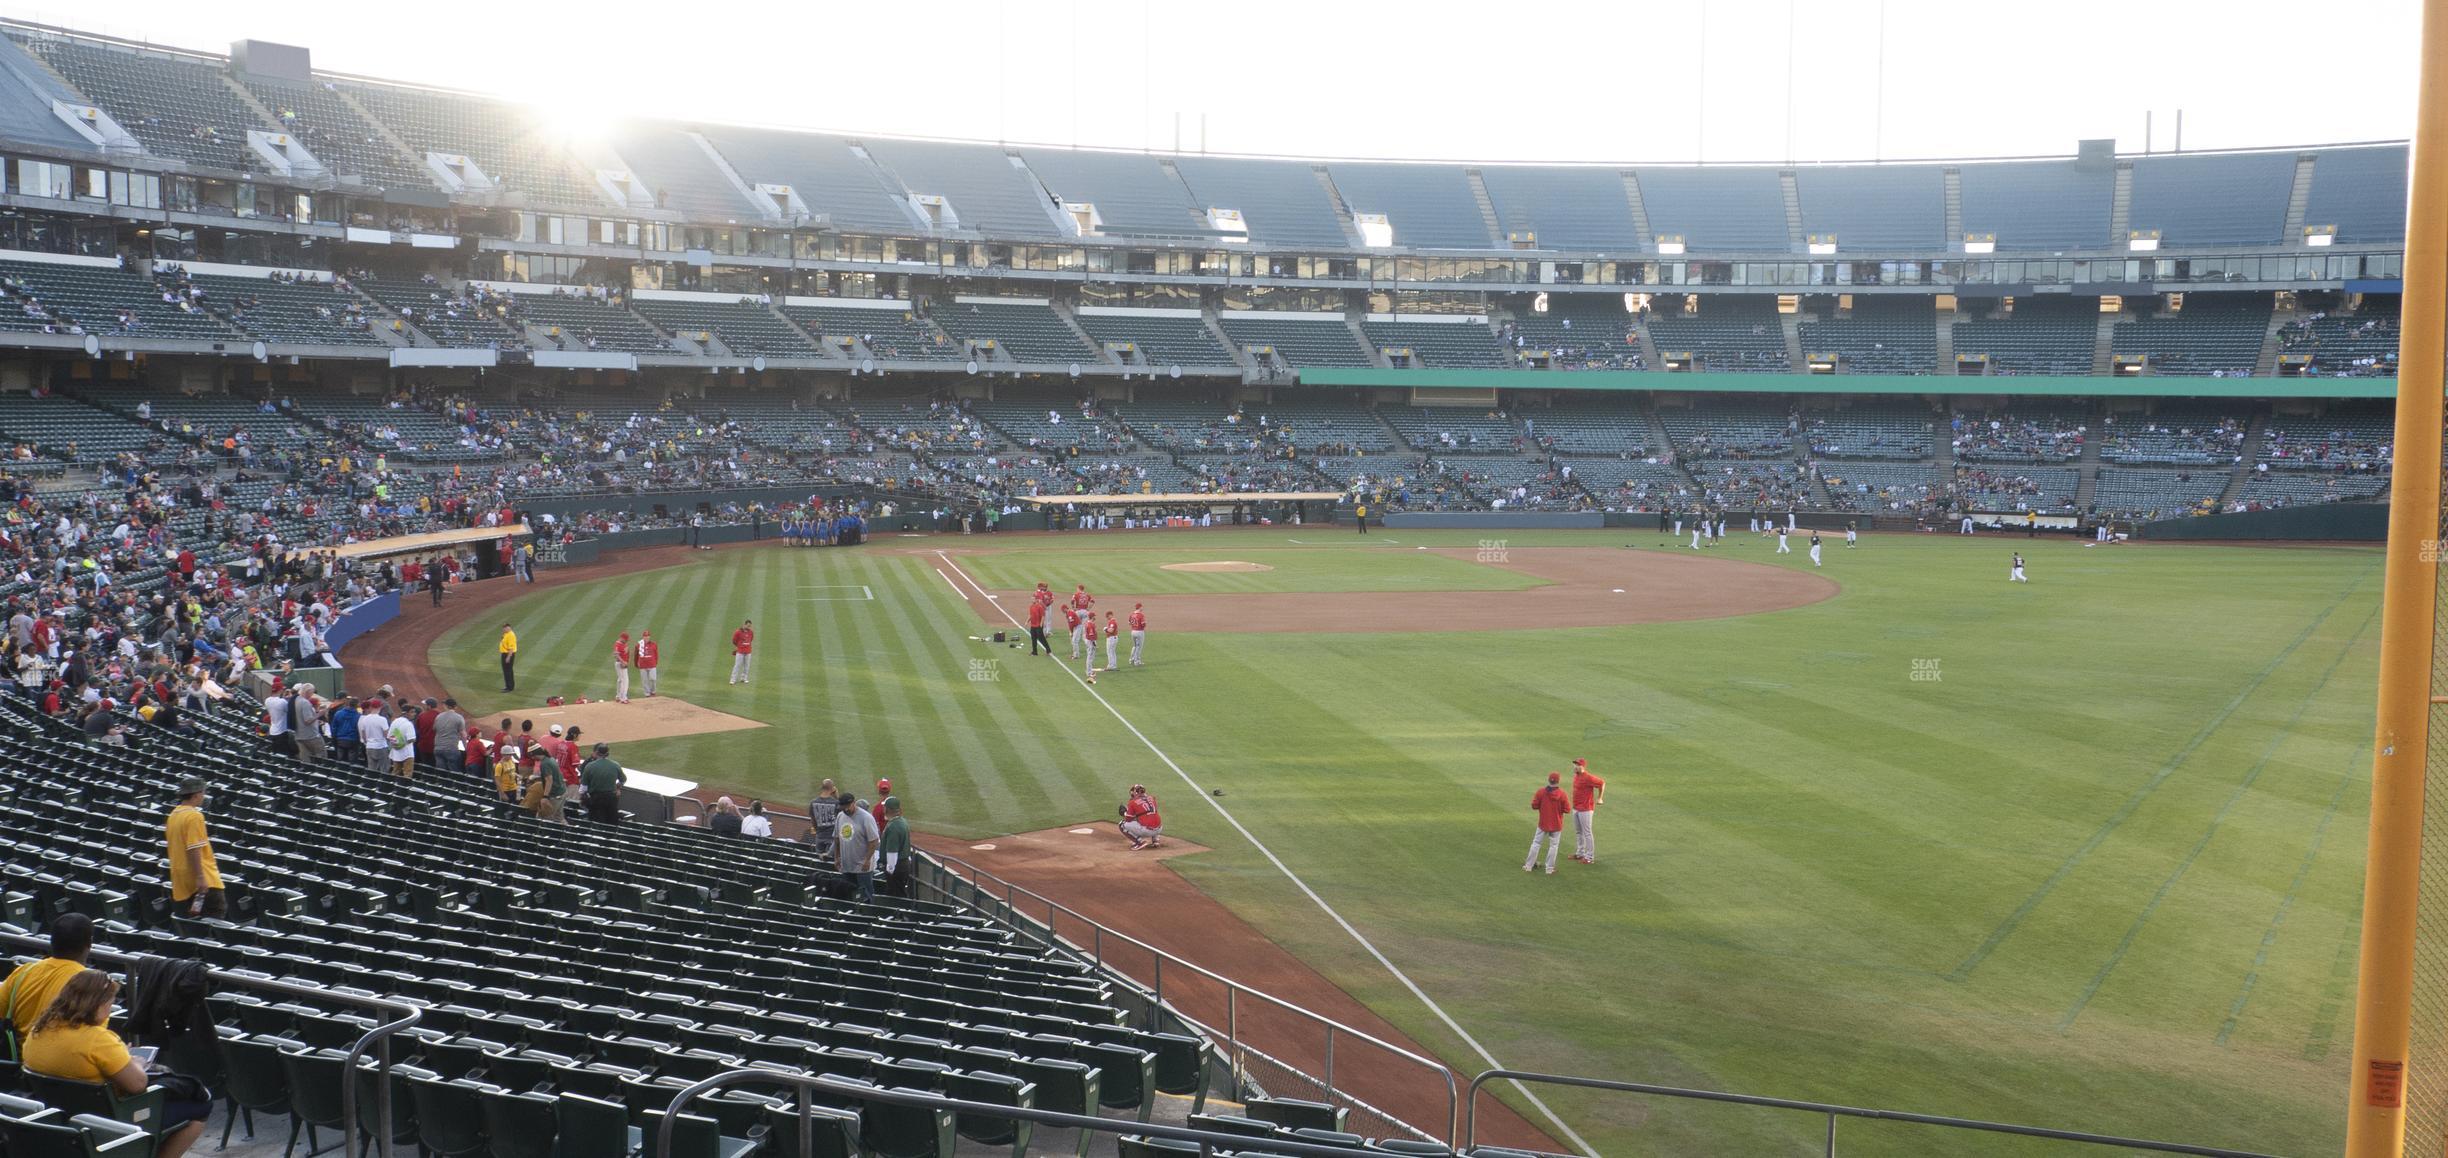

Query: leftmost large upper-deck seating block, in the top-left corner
[10,29,272,171]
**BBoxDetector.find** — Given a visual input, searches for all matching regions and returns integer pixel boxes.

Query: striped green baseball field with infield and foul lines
[431,526,2379,1156]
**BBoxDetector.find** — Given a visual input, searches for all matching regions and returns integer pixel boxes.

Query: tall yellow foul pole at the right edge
[2345,0,2448,1158]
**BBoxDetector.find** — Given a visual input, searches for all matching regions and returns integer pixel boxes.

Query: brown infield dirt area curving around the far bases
[945,546,1838,634]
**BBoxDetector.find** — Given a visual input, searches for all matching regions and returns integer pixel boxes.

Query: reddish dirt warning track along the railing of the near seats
[918,825,1572,1153]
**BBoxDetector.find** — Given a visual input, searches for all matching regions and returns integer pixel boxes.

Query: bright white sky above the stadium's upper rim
[14,0,2419,162]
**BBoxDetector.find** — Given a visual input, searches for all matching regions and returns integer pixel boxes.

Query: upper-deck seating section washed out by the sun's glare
[340,78,605,208]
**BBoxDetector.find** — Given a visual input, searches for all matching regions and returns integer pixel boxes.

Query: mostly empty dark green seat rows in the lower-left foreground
[0,680,1209,1158]
